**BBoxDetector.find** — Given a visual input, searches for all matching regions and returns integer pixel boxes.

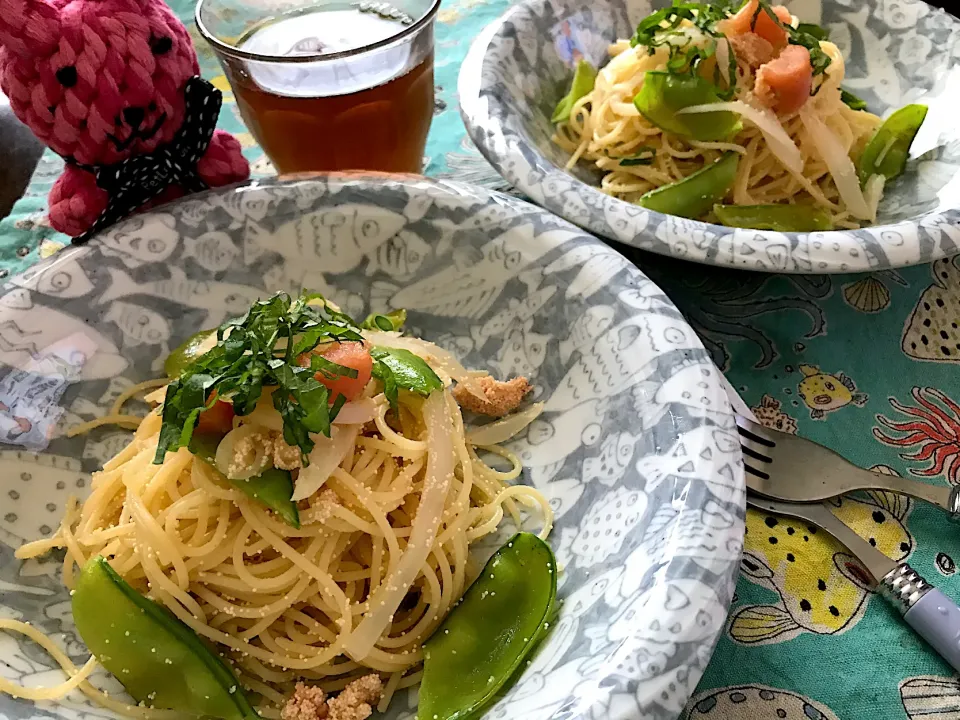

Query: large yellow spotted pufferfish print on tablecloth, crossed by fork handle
[729,486,913,644]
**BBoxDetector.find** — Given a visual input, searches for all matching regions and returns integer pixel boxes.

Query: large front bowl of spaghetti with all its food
[0,176,744,720]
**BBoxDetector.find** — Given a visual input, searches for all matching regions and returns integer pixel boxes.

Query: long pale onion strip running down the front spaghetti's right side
[343,391,453,662]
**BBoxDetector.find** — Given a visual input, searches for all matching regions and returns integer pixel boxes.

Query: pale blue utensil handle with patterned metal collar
[879,563,960,671]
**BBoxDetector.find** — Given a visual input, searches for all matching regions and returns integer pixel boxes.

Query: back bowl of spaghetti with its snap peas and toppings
[460,0,960,273]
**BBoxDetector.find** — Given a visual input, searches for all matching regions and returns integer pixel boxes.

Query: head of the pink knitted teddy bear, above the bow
[0,0,199,165]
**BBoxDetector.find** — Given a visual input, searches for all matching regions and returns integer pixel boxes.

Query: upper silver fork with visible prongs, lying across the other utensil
[737,415,960,521]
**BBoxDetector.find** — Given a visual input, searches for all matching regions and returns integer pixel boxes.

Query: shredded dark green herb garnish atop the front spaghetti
[154,293,363,464]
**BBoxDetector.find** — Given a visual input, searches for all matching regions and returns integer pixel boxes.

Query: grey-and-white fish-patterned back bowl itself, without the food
[458,0,960,273]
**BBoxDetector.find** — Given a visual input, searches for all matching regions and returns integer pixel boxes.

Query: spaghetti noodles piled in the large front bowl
[0,294,552,720]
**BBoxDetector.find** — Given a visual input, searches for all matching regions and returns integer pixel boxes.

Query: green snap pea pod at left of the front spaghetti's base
[71,556,259,720]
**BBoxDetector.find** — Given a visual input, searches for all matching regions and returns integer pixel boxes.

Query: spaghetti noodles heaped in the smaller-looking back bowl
[554,0,881,228]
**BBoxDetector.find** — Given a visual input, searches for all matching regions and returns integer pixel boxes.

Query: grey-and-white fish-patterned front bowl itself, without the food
[0,176,744,720]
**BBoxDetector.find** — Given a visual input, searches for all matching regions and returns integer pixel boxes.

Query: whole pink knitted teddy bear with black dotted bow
[0,0,250,242]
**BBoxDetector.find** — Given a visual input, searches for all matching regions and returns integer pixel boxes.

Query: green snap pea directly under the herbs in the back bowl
[633,70,743,142]
